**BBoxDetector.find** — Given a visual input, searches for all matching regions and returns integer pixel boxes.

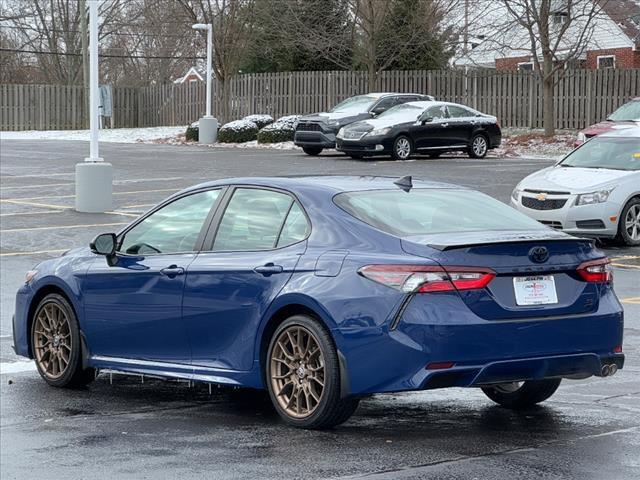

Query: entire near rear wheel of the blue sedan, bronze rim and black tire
[265,315,359,429]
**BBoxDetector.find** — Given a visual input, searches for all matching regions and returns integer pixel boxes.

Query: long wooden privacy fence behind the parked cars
[0,70,640,130]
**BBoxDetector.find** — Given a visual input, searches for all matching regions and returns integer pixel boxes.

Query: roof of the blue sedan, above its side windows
[179,175,467,194]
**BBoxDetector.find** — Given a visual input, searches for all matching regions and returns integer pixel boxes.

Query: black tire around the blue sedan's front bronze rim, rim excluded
[30,293,96,388]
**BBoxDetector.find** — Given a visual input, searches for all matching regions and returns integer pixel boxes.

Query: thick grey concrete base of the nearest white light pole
[76,159,113,213]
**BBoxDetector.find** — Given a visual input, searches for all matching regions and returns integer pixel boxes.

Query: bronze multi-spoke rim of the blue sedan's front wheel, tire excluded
[33,302,71,380]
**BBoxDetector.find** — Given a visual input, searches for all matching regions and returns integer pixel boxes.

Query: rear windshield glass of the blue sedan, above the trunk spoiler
[334,189,547,237]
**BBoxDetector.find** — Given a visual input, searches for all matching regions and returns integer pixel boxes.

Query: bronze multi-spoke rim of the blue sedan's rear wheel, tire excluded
[270,325,325,419]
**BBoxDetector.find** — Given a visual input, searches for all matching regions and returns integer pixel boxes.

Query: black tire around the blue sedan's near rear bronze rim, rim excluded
[265,315,359,429]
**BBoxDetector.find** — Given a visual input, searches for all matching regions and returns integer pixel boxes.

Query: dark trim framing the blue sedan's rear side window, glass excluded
[200,184,313,253]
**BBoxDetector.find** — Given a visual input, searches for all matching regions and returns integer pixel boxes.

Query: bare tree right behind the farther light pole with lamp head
[177,0,253,122]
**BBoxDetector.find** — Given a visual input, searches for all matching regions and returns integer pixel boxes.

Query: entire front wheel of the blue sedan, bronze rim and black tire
[31,293,95,388]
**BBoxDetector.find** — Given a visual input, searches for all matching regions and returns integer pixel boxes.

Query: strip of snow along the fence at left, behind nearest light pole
[0,126,185,143]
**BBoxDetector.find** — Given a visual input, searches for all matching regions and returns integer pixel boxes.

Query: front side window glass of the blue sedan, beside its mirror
[119,190,220,255]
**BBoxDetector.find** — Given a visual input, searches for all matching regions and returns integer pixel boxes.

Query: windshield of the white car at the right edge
[560,137,640,170]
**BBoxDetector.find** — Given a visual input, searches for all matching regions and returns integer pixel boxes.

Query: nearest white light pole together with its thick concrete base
[76,0,113,213]
